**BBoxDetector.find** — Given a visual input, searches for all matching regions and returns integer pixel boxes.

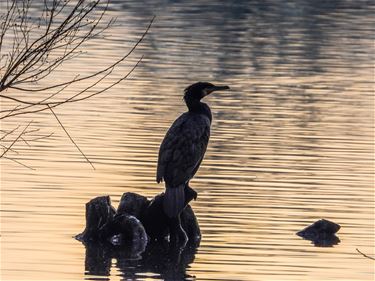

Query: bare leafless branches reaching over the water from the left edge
[0,0,155,169]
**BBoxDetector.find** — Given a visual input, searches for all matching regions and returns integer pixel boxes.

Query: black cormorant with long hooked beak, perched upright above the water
[156,82,229,240]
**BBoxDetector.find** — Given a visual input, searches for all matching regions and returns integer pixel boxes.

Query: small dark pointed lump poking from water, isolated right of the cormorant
[297,219,340,247]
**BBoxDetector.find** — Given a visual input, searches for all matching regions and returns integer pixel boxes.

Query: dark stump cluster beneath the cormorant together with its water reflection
[76,190,200,280]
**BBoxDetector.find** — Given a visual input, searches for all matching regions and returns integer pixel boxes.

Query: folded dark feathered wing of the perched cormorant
[156,113,210,187]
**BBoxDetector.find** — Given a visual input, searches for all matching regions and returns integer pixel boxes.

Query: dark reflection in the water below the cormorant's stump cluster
[84,237,200,281]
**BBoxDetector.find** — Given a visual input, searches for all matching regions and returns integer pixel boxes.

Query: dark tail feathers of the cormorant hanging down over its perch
[163,184,185,218]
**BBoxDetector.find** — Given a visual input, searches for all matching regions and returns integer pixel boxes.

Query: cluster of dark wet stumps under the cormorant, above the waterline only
[76,187,201,246]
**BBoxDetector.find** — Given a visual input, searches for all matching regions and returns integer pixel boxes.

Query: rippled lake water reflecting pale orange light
[0,0,374,281]
